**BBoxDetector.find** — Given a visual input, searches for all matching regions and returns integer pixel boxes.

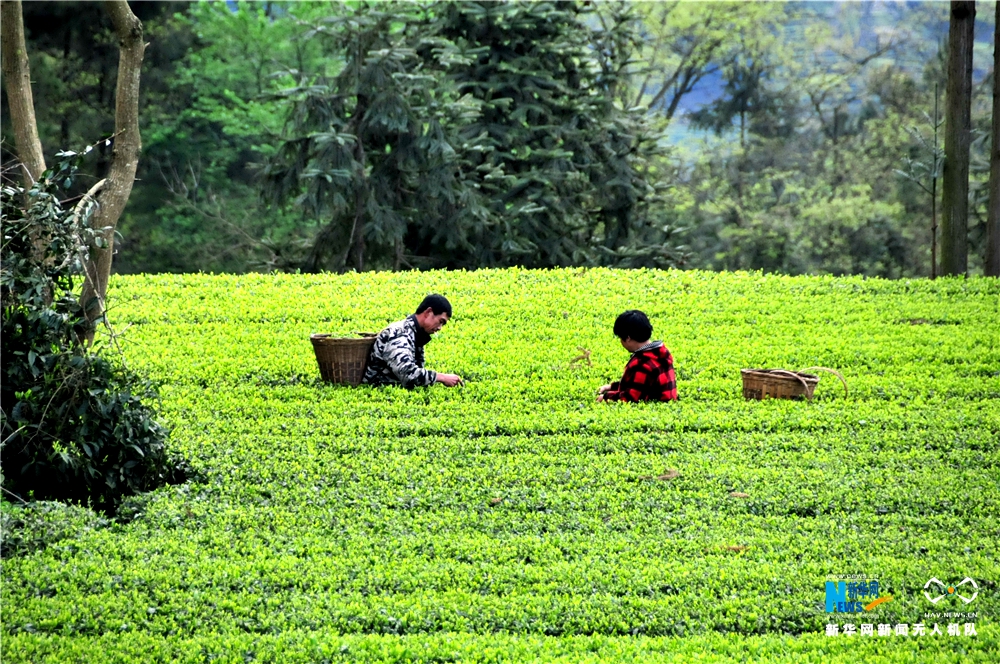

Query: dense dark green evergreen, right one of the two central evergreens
[443,2,670,267]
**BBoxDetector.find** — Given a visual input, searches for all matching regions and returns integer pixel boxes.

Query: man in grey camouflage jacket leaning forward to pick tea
[361,294,462,389]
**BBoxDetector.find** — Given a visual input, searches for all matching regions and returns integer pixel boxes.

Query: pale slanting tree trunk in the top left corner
[0,0,45,184]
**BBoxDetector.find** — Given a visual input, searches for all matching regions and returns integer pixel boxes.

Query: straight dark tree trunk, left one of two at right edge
[941,2,976,275]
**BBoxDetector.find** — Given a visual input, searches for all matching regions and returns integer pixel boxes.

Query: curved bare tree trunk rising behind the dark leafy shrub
[80,0,146,330]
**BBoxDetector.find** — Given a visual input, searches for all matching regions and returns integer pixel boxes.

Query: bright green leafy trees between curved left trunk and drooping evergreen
[133,3,318,272]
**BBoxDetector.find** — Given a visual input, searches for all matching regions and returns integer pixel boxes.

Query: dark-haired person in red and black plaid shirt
[597,309,677,402]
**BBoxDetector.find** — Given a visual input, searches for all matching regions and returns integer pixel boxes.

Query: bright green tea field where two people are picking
[0,269,1000,664]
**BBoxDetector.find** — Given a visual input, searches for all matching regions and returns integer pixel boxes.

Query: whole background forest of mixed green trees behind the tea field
[2,2,994,277]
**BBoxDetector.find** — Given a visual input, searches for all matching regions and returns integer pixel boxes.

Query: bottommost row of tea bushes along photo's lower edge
[12,632,1000,664]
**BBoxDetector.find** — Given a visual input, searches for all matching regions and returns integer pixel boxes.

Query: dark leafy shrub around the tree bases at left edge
[0,153,179,508]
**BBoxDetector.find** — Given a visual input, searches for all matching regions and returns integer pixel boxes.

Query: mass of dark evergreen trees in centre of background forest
[264,2,678,272]
